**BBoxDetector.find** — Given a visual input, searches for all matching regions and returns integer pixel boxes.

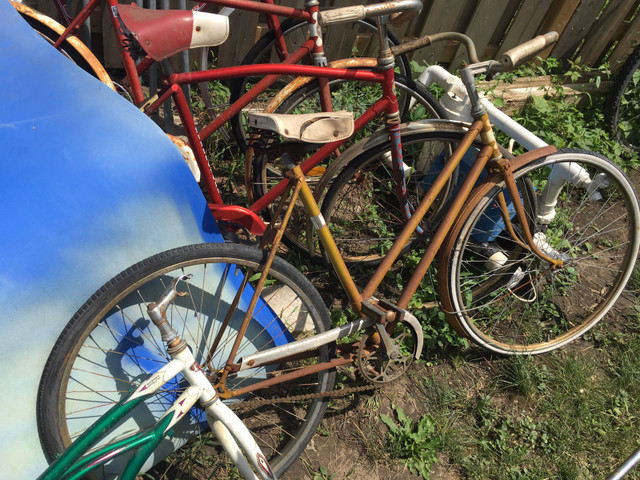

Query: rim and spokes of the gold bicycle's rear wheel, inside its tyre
[48,251,329,472]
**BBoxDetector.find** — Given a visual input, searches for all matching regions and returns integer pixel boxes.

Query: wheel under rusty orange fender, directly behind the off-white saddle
[252,75,445,261]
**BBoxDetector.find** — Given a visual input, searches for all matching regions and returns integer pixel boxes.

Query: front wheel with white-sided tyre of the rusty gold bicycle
[451,154,638,353]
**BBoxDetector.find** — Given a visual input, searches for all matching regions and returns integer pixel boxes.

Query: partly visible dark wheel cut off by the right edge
[606,47,640,152]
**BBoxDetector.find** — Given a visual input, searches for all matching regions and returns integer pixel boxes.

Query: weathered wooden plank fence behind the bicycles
[31,0,640,70]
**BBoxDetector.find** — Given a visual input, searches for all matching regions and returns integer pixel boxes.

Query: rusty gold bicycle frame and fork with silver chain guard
[208,58,563,398]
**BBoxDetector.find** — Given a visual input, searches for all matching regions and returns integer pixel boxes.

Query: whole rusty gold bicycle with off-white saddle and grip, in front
[38,13,640,474]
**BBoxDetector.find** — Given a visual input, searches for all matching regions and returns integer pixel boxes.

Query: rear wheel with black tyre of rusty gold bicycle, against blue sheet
[37,243,335,477]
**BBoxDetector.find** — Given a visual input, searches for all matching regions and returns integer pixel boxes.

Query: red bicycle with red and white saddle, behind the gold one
[13,2,443,258]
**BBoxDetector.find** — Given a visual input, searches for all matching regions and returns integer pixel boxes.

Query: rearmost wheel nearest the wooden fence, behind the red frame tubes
[222,18,411,151]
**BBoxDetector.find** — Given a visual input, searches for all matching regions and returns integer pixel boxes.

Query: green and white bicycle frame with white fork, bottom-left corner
[38,276,275,480]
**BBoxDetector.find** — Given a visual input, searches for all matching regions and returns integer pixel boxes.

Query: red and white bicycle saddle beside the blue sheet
[118,4,229,61]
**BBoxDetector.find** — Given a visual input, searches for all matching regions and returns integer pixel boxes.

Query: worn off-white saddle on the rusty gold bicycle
[249,110,353,143]
